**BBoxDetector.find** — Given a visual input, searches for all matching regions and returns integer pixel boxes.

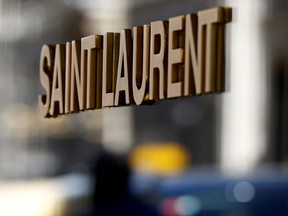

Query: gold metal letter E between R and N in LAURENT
[167,16,185,98]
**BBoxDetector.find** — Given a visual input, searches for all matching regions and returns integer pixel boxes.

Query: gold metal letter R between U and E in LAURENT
[149,21,167,100]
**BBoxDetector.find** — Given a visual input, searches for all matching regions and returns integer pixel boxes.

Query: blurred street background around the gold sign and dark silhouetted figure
[0,0,288,216]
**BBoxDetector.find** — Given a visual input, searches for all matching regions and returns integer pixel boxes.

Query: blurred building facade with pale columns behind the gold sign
[0,0,288,180]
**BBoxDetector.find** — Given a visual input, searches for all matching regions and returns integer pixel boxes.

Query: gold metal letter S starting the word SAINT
[38,45,55,118]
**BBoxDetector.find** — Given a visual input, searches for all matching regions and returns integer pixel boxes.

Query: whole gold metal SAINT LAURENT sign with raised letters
[39,7,232,117]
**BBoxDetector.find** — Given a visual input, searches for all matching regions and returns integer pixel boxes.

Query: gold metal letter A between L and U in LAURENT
[114,29,134,106]
